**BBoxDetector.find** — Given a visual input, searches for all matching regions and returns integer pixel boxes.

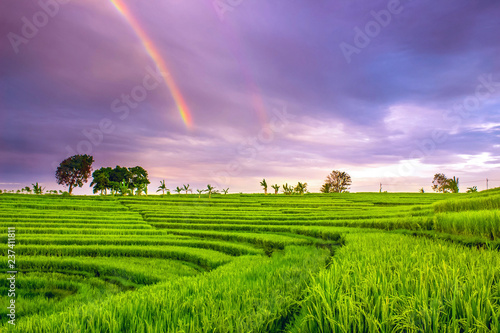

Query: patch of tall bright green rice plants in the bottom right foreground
[292,233,500,332]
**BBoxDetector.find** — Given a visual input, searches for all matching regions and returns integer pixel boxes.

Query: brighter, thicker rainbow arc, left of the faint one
[110,0,193,128]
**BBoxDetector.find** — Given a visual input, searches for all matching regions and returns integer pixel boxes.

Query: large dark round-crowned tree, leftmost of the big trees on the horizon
[56,155,94,195]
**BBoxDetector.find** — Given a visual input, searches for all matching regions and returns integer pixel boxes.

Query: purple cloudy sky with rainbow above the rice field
[0,0,500,194]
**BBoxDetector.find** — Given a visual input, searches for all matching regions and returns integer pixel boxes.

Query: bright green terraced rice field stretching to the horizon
[0,190,500,333]
